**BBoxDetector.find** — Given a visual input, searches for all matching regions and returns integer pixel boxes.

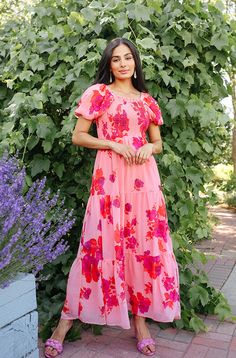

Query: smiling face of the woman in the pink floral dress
[110,44,135,80]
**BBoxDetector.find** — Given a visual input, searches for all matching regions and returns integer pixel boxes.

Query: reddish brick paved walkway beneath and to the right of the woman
[39,207,236,358]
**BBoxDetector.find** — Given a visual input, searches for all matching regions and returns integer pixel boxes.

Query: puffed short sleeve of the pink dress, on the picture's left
[75,83,113,121]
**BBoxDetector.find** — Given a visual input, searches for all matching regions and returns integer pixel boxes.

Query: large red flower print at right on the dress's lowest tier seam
[136,250,163,279]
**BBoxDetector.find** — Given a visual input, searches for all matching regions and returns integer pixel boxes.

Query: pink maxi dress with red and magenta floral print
[62,84,180,328]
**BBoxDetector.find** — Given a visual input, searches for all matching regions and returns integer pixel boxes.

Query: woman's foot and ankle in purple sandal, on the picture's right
[133,315,156,355]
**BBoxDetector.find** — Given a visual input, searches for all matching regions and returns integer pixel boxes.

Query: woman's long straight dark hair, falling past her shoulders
[93,37,147,92]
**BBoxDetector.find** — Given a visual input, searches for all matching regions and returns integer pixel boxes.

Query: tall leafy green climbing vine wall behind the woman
[0,0,235,331]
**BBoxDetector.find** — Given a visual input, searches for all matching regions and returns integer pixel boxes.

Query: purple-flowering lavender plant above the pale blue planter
[0,154,75,287]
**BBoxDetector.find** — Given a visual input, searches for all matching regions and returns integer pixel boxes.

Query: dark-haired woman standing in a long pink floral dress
[45,38,180,357]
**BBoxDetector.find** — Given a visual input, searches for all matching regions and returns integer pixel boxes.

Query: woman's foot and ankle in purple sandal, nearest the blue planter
[44,319,73,358]
